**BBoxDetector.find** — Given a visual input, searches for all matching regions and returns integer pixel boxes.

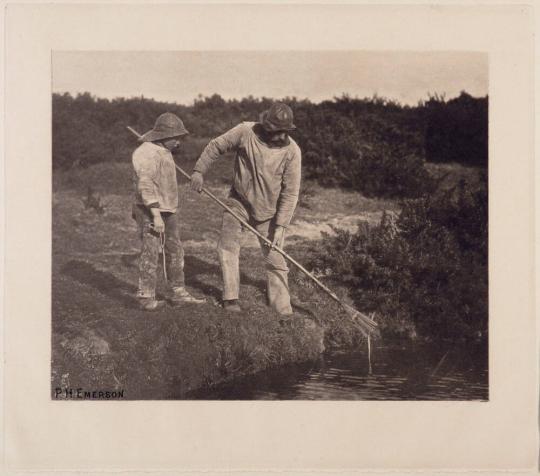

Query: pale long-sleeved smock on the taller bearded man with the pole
[193,122,302,227]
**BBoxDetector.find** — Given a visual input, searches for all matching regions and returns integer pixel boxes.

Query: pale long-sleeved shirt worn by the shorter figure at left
[132,142,178,213]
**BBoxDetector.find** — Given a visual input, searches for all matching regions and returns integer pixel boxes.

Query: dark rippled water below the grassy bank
[190,342,488,401]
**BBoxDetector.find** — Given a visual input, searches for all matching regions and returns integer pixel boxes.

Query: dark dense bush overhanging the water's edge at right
[312,177,488,341]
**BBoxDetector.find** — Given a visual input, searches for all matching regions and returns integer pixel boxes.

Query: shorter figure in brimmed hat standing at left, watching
[132,112,204,311]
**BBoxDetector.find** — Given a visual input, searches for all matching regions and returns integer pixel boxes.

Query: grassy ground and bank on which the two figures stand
[52,149,402,399]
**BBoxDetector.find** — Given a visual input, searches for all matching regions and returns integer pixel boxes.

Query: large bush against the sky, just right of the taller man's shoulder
[295,96,432,197]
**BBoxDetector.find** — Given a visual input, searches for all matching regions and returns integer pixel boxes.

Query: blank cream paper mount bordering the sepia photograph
[2,3,538,474]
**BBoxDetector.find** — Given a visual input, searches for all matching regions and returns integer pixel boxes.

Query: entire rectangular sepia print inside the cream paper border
[51,51,489,401]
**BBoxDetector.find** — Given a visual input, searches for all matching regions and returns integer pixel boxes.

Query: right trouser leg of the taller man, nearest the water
[255,220,292,314]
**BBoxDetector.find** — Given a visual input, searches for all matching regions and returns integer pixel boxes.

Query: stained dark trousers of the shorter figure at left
[133,205,185,298]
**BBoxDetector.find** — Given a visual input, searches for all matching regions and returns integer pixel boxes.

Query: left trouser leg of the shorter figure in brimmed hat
[134,205,160,298]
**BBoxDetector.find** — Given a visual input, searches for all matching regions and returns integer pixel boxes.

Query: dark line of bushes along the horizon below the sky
[52,92,488,197]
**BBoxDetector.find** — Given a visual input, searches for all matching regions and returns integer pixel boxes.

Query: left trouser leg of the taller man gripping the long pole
[217,199,248,301]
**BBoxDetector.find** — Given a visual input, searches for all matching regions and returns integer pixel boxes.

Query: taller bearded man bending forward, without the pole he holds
[191,102,301,315]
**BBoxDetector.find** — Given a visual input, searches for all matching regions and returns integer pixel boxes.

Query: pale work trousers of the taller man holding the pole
[218,198,292,314]
